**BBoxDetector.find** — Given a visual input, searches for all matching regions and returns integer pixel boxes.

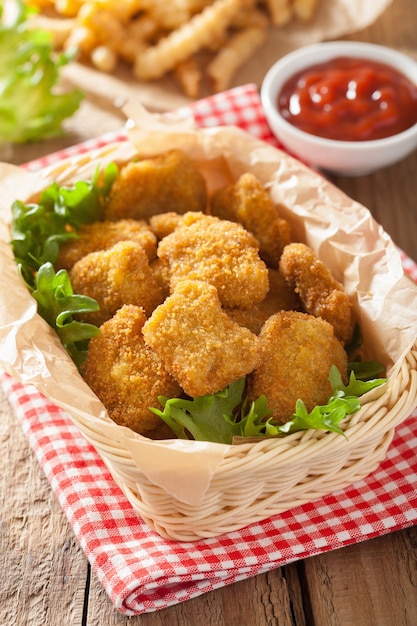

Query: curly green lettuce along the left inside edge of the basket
[11,163,118,368]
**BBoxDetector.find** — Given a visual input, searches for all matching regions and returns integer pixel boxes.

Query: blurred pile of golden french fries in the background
[25,0,319,99]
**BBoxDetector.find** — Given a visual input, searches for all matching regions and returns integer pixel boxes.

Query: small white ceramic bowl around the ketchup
[261,41,417,176]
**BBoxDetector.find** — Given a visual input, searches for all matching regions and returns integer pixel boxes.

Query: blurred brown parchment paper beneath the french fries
[63,0,392,111]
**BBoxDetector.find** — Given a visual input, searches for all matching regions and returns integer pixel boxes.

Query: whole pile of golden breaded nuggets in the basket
[57,150,353,439]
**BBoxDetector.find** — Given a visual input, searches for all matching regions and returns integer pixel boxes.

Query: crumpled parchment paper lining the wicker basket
[0,101,417,505]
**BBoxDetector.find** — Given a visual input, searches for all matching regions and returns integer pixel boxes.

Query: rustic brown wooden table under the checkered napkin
[0,0,417,626]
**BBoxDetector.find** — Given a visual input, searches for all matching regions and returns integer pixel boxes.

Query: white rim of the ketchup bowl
[260,40,417,152]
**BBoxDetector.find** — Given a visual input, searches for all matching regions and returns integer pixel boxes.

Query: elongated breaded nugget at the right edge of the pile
[279,243,354,345]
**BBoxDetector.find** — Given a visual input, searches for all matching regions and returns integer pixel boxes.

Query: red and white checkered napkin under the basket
[0,85,417,615]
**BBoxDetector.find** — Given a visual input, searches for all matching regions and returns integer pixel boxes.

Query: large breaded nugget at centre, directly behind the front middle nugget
[157,215,268,307]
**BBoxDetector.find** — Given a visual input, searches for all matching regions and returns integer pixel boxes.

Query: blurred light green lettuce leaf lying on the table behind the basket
[0,0,83,143]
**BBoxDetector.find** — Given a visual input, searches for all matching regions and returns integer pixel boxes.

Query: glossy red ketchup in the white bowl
[277,57,417,141]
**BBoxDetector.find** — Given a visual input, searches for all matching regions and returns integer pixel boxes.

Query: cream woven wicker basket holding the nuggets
[3,125,417,541]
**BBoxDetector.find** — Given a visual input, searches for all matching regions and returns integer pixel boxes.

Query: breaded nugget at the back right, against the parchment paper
[210,172,291,268]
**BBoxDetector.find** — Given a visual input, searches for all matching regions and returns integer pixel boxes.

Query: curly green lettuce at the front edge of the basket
[151,366,386,444]
